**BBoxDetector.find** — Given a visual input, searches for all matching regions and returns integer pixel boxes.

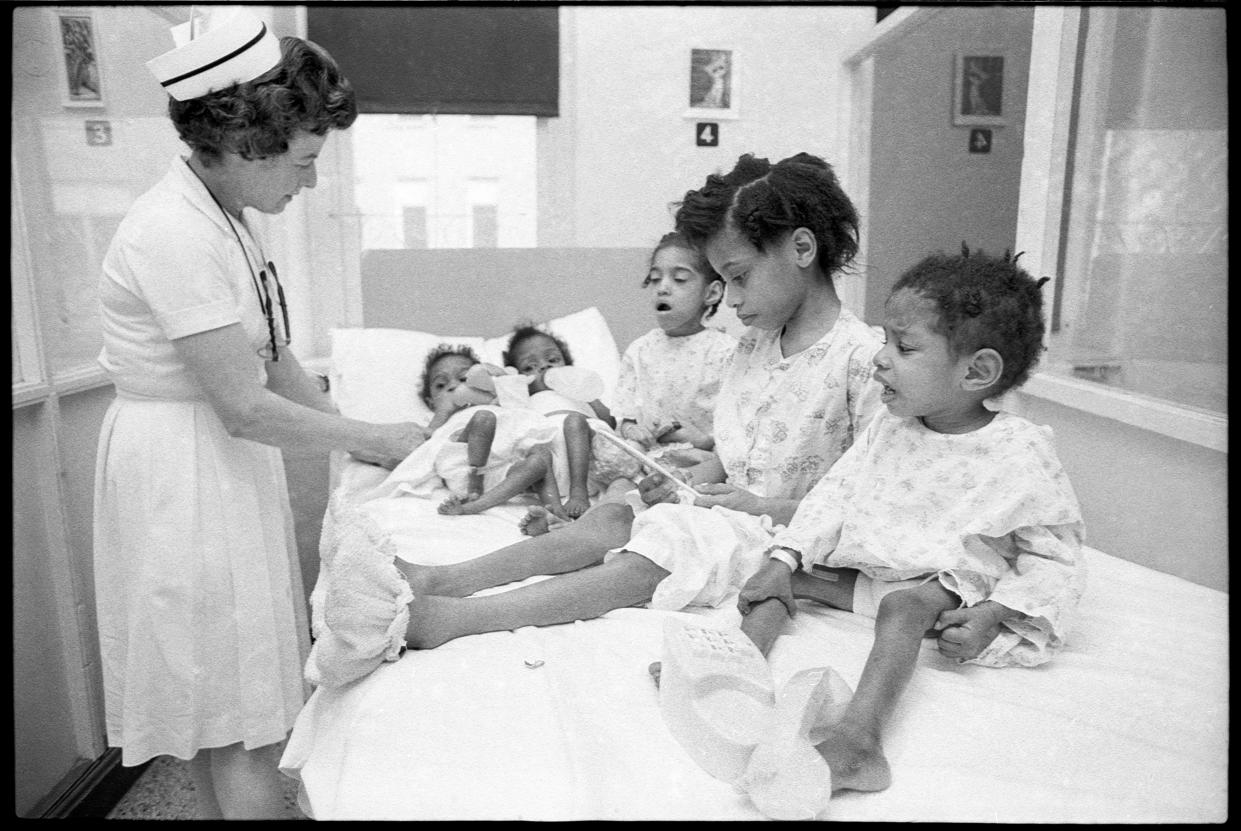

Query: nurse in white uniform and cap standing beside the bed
[94,6,426,819]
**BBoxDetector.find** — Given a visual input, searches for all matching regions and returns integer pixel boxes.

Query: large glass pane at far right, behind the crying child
[1041,7,1229,413]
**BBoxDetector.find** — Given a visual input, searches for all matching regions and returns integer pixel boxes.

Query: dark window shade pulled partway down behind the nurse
[307,4,560,115]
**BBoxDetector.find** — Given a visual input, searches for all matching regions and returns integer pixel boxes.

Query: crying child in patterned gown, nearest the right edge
[738,252,1085,813]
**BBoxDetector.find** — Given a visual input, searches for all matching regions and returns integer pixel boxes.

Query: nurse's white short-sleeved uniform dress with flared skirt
[94,158,309,765]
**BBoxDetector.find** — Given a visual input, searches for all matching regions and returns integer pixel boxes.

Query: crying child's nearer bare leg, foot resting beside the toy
[812,578,959,790]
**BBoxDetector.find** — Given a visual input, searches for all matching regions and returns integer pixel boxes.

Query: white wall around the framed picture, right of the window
[539,5,875,248]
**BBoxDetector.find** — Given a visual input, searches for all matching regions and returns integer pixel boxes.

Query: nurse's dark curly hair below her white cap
[168,37,357,166]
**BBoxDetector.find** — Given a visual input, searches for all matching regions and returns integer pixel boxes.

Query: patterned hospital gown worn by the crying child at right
[772,409,1085,666]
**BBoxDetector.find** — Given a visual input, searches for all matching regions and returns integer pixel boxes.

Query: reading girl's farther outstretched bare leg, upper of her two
[396,505,633,598]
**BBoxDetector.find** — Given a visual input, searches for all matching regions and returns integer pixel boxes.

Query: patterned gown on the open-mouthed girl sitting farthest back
[612,329,737,435]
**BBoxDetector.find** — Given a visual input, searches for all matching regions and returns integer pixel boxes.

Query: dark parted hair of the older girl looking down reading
[676,153,858,277]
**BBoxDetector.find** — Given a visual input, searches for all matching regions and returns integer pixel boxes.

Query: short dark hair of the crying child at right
[892,243,1051,396]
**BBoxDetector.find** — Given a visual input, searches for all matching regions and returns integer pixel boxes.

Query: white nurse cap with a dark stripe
[146,6,280,100]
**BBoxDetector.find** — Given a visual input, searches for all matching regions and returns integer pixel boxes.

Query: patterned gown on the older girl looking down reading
[609,310,882,609]
